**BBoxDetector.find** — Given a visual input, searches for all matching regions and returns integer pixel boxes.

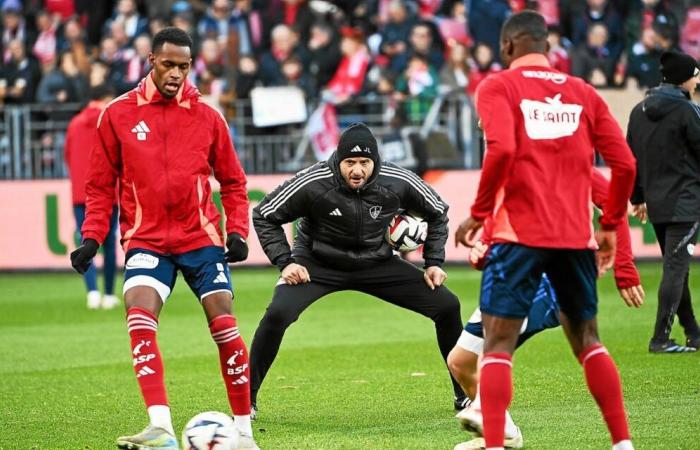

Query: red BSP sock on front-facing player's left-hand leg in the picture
[126,307,168,407]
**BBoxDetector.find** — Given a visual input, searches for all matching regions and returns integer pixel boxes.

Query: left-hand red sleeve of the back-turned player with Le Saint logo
[471,78,516,220]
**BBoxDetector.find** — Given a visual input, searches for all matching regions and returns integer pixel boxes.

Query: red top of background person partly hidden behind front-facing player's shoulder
[63,101,105,205]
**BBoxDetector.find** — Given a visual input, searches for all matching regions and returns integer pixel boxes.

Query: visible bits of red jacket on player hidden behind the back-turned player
[472,169,641,289]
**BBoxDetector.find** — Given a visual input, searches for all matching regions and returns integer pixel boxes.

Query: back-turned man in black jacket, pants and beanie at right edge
[627,52,700,353]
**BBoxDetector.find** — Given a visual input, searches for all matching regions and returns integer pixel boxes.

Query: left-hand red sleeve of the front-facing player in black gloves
[81,107,122,244]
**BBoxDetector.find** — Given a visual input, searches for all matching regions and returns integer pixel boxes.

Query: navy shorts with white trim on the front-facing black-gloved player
[124,246,233,302]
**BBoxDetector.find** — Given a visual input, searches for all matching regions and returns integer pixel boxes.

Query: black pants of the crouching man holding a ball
[250,256,464,402]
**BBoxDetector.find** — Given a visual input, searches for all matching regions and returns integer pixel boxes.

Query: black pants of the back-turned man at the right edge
[651,222,700,344]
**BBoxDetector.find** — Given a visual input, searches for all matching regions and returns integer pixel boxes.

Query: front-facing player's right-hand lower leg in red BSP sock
[202,292,253,439]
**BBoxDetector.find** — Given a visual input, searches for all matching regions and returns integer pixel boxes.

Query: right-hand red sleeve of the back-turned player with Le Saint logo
[587,86,636,230]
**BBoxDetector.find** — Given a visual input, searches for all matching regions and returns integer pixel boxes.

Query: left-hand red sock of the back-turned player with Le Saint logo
[479,353,513,448]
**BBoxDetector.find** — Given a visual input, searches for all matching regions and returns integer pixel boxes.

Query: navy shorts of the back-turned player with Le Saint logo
[479,244,598,322]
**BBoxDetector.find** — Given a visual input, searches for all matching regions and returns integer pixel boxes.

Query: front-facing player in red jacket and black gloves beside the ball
[71,27,257,450]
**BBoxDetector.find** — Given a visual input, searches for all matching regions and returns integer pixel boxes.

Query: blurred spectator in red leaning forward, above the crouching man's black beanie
[322,27,370,105]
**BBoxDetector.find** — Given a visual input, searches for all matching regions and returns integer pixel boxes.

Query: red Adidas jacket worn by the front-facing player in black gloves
[82,74,249,254]
